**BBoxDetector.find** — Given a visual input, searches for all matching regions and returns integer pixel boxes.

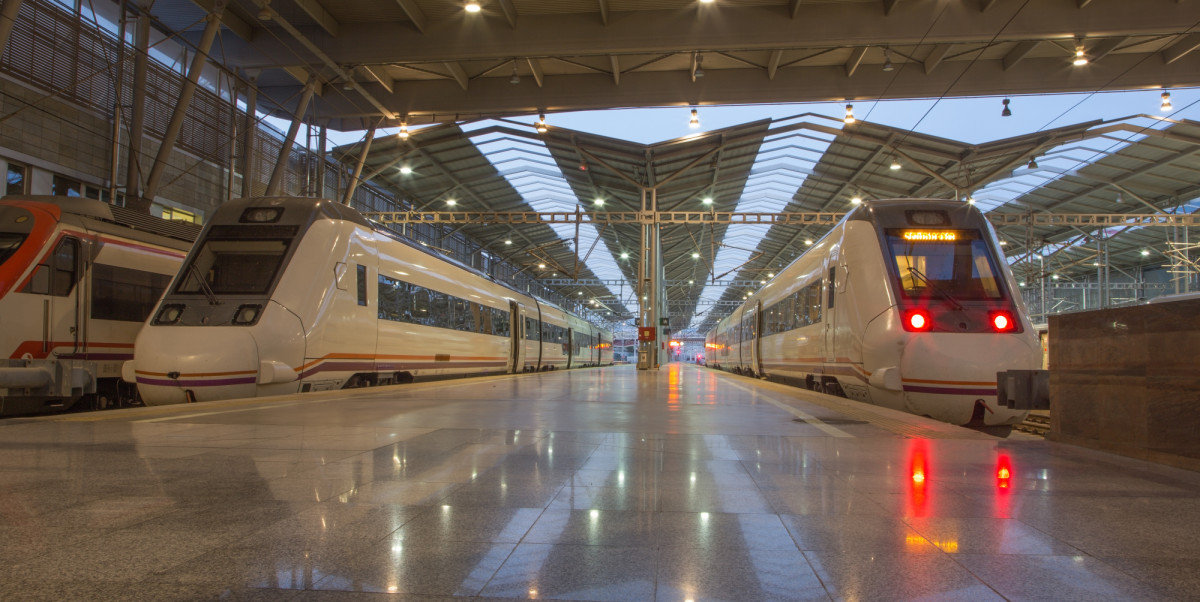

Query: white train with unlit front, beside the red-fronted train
[122,197,612,405]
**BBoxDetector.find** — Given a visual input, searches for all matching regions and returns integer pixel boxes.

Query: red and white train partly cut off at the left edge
[0,197,200,416]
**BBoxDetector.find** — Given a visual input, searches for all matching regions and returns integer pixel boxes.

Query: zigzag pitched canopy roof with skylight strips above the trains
[334,114,1200,335]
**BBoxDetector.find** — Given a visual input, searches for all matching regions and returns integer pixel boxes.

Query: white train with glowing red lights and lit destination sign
[706,199,1042,432]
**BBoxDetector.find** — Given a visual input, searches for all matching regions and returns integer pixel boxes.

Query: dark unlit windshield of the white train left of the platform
[175,239,290,295]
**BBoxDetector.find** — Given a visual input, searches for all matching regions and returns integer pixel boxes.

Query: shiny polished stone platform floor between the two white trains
[0,363,1200,602]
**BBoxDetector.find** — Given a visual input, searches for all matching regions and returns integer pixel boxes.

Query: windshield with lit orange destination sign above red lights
[886,229,1004,300]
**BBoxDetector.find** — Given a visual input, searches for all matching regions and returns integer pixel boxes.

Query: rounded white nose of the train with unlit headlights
[133,326,259,405]
